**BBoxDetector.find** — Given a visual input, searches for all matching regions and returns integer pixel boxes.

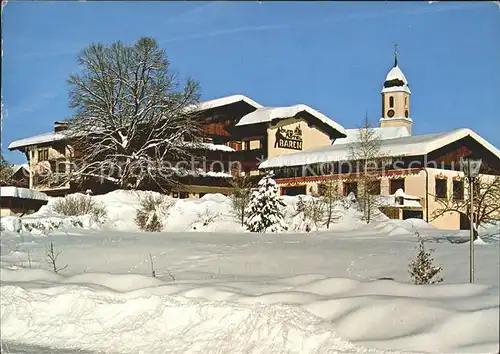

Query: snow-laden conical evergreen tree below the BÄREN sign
[245,173,287,232]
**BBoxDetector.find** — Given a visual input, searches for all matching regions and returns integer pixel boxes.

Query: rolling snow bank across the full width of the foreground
[1,270,499,353]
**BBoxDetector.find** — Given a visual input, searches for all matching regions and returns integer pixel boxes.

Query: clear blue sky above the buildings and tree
[2,1,500,163]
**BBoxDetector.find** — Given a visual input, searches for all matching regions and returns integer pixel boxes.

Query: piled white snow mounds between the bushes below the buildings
[7,190,378,232]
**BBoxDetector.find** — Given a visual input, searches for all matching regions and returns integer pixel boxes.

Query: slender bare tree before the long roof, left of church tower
[349,116,383,224]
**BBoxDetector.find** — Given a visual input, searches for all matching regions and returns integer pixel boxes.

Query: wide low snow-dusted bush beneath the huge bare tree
[51,194,108,223]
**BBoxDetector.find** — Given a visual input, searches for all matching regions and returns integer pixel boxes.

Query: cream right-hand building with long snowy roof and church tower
[259,51,500,229]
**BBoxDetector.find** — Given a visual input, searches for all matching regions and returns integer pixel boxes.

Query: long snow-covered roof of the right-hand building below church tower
[259,129,500,169]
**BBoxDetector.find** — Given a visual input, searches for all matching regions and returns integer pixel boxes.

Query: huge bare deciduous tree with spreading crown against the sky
[66,38,201,189]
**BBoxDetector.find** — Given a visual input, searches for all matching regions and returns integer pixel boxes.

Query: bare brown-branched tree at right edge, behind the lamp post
[431,176,500,238]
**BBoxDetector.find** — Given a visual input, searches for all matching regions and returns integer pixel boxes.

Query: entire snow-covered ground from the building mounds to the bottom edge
[0,191,500,353]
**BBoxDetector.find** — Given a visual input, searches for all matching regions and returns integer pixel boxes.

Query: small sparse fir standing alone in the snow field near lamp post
[408,234,443,285]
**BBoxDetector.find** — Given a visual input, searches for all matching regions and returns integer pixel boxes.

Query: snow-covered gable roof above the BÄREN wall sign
[236,104,345,134]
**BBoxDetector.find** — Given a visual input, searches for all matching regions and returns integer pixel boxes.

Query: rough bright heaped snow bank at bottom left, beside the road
[1,286,374,354]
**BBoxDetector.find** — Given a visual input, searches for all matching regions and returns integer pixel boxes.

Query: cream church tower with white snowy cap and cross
[380,43,413,135]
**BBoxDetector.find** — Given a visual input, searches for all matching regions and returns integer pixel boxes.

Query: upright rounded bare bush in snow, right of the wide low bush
[135,194,174,232]
